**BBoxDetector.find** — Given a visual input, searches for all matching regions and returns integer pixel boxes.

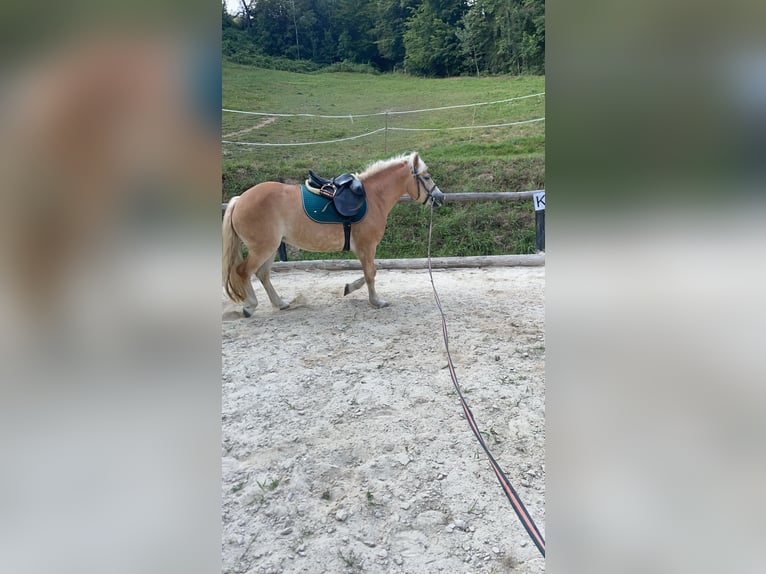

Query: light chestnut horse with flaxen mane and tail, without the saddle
[223,152,444,317]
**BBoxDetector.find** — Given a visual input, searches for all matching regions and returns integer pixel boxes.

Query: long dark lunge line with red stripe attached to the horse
[426,205,545,558]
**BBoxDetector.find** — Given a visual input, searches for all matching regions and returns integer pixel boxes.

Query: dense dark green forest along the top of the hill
[222,0,545,77]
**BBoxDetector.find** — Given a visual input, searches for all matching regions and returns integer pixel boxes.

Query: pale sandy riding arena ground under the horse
[222,267,545,574]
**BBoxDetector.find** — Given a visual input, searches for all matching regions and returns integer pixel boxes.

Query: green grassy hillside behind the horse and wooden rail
[222,62,545,259]
